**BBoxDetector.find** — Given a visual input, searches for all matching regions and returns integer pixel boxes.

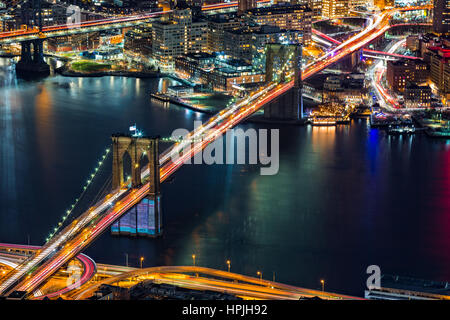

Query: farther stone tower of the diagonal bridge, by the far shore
[264,43,303,121]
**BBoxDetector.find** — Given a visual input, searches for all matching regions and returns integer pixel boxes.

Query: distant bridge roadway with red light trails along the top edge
[0,0,270,44]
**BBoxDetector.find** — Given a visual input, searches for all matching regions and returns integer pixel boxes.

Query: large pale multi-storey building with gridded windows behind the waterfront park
[152,8,208,72]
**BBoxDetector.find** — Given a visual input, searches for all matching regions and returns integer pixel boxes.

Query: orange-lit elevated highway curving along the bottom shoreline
[0,243,359,300]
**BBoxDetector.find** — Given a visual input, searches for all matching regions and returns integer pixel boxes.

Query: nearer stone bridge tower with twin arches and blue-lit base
[111,134,162,237]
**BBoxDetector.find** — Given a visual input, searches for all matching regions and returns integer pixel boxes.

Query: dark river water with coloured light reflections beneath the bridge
[0,60,450,296]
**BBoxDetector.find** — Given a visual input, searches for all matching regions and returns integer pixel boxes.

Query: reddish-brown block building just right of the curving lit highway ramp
[386,59,429,92]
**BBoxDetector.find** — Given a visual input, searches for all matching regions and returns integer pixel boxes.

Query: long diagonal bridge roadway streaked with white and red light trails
[0,3,430,294]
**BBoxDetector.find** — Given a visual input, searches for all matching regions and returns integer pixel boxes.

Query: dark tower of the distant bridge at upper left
[16,0,50,75]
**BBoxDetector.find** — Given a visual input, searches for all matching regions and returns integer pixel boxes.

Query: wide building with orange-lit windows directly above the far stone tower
[247,4,312,45]
